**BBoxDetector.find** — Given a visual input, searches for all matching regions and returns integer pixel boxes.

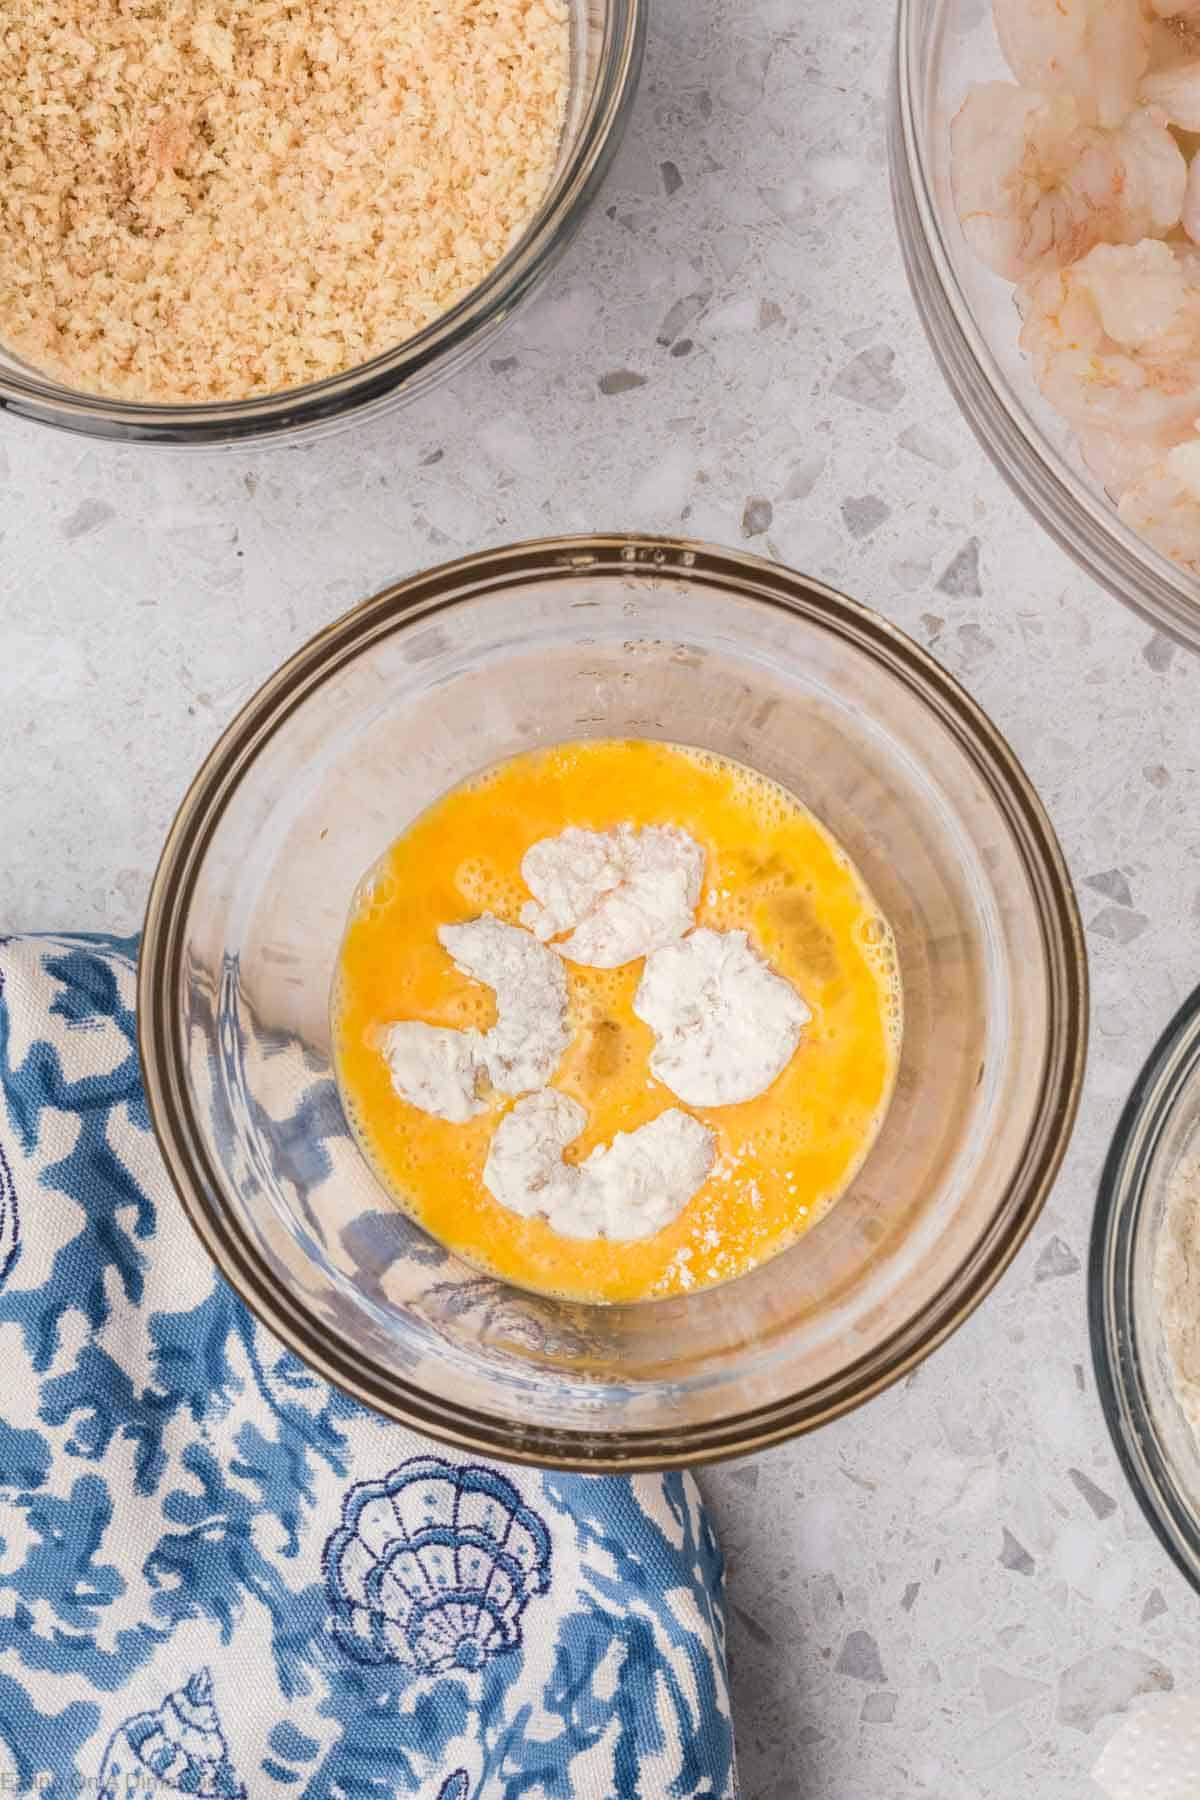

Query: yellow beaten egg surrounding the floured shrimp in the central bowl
[333,740,901,1301]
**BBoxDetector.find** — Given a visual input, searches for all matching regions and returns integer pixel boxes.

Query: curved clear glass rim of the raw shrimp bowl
[887,0,1200,650]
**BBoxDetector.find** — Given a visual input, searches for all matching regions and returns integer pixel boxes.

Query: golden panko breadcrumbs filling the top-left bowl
[0,0,569,403]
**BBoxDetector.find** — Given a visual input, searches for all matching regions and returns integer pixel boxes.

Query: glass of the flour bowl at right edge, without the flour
[1088,988,1200,1591]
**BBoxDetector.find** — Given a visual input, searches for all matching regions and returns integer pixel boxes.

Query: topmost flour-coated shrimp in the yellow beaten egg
[522,824,703,968]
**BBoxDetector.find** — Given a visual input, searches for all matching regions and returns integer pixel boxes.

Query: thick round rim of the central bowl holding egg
[139,535,1088,1472]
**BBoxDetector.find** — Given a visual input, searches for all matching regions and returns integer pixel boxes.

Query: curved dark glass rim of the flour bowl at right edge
[1087,986,1200,1593]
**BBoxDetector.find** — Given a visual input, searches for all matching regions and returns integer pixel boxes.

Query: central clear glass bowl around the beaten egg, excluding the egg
[140,536,1087,1469]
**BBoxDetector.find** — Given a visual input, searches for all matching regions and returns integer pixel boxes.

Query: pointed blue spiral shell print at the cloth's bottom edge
[99,1669,246,1800]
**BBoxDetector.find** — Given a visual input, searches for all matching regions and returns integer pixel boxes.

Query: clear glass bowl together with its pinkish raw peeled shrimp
[891,0,1200,648]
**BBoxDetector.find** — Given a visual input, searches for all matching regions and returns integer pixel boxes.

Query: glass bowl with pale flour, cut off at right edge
[1088,988,1200,1589]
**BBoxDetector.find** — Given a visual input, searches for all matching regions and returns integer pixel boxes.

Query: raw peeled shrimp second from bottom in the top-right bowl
[1020,238,1200,452]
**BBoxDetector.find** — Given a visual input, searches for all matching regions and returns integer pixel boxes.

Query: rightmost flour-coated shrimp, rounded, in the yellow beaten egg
[633,927,811,1107]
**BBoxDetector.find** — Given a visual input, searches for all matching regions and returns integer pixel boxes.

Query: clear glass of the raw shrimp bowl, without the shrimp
[889,0,1200,648]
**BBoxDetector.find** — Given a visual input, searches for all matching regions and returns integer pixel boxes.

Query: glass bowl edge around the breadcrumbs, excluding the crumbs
[0,0,646,446]
